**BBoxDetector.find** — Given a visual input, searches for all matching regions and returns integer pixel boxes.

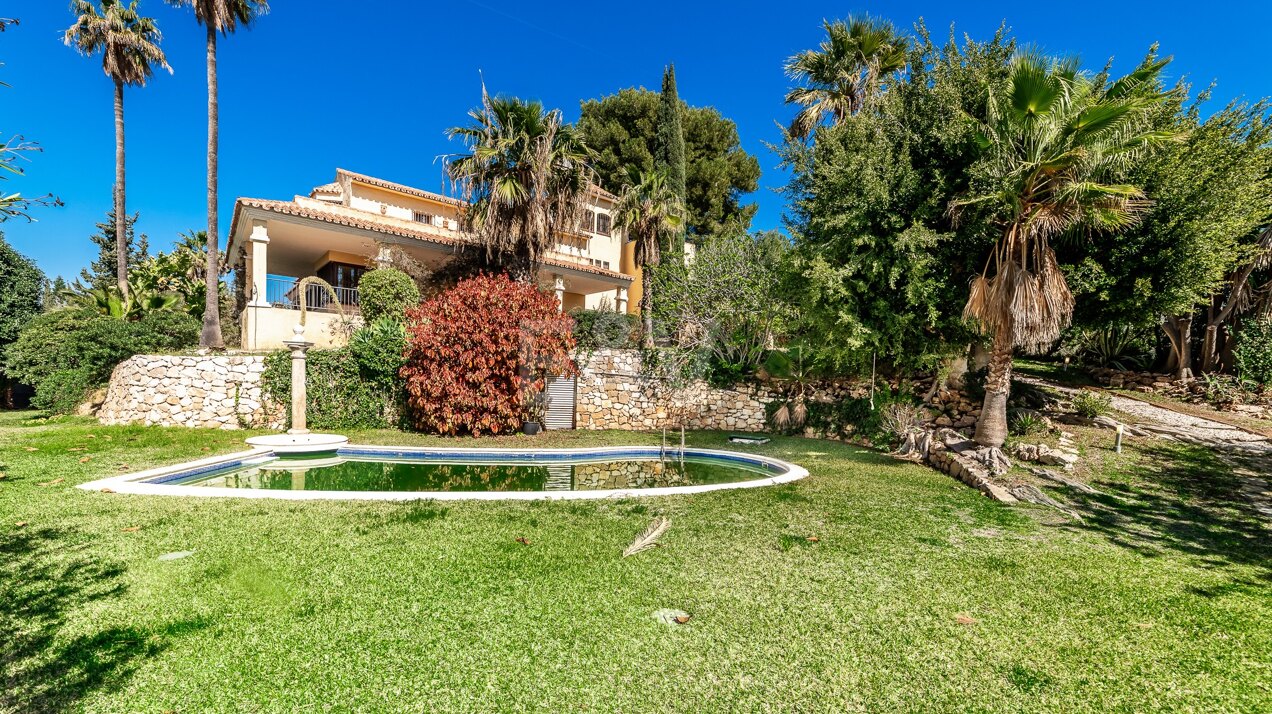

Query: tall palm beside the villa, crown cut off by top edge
[168,0,270,350]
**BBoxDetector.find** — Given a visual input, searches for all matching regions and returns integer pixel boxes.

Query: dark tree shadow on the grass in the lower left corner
[0,528,202,711]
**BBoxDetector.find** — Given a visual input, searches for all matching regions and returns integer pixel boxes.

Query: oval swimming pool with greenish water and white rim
[80,445,808,500]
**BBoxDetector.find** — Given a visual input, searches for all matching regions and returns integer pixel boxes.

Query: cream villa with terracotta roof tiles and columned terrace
[225,169,640,350]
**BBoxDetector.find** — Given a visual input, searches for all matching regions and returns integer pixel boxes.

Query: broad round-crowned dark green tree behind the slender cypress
[579,89,759,235]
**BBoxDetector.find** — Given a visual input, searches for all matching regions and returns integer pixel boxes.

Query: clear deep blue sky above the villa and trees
[0,0,1272,277]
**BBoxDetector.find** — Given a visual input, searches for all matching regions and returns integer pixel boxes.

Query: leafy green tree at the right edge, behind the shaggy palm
[1058,91,1272,327]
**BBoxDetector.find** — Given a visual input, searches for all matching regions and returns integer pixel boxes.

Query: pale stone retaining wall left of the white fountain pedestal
[97,355,282,429]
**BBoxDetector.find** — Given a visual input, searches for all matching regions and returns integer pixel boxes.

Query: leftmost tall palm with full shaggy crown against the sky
[64,0,172,302]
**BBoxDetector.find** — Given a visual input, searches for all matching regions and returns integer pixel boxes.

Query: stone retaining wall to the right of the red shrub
[575,350,776,431]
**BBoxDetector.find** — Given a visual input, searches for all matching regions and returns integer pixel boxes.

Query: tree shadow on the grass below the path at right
[1072,444,1272,588]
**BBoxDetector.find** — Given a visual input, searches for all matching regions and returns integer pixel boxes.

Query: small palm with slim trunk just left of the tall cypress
[614,171,684,347]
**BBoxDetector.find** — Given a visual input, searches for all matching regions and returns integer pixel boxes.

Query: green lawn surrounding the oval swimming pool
[0,414,1272,713]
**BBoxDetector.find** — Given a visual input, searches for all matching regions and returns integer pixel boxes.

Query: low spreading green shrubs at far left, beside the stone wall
[5,309,198,412]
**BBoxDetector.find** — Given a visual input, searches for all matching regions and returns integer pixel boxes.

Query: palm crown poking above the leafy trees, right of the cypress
[786,15,909,139]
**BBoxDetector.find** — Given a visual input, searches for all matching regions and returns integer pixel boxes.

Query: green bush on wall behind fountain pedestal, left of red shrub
[261,347,402,430]
